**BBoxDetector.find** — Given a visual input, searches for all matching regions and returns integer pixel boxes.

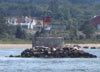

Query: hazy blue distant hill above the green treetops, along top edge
[0,0,100,4]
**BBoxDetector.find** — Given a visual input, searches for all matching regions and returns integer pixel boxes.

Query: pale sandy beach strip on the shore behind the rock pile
[0,43,100,49]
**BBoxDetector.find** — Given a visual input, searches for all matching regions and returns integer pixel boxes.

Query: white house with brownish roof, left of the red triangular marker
[7,16,36,29]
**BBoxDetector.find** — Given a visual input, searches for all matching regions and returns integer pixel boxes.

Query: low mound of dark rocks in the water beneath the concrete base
[9,46,97,58]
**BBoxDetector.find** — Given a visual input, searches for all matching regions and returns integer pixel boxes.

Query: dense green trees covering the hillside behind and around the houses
[0,0,100,41]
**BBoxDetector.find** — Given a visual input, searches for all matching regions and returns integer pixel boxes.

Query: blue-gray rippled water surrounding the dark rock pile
[0,49,100,72]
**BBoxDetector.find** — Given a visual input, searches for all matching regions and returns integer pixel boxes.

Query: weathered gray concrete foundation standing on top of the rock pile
[32,37,64,48]
